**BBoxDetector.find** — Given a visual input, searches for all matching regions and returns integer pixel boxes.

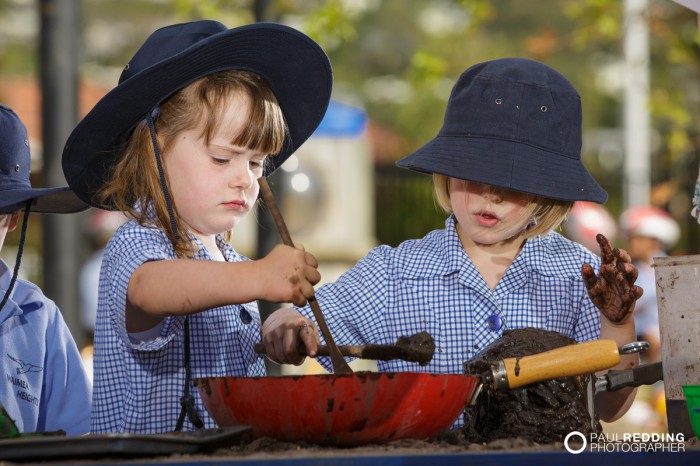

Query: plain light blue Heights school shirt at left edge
[0,260,92,436]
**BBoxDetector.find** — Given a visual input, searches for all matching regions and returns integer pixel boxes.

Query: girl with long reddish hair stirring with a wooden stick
[63,20,332,433]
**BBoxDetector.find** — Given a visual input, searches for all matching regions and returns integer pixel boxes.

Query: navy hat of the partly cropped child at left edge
[0,105,88,215]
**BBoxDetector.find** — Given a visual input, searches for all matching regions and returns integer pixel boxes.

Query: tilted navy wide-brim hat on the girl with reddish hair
[62,20,333,209]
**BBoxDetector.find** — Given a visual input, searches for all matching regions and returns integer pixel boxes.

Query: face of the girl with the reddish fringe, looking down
[163,93,266,236]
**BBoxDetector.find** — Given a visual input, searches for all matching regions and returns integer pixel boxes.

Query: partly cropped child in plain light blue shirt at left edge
[0,105,91,436]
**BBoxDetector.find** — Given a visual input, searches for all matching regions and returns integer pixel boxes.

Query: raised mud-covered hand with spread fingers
[581,234,642,323]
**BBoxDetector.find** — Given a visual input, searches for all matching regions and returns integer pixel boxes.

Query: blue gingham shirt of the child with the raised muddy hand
[300,216,600,420]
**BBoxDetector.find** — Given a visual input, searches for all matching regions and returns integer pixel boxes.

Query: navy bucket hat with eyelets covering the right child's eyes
[397,58,608,204]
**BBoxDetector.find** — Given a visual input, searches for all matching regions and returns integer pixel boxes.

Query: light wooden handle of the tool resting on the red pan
[503,340,620,388]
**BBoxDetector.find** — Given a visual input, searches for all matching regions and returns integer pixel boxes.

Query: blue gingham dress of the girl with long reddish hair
[91,220,265,433]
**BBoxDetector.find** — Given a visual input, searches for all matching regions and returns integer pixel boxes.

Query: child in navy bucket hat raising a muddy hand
[263,58,641,425]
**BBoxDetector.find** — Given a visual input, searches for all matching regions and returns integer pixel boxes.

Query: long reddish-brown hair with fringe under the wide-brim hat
[97,70,287,257]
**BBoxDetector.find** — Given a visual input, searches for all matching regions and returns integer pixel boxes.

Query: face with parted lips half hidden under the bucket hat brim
[449,178,531,245]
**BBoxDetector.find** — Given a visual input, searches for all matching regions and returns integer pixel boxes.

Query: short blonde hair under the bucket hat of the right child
[433,173,574,239]
